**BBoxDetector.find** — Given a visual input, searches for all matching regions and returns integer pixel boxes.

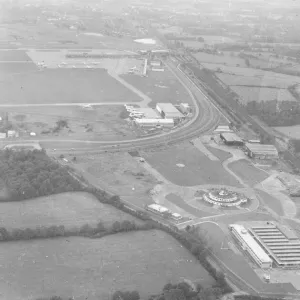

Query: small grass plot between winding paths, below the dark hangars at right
[228,159,269,186]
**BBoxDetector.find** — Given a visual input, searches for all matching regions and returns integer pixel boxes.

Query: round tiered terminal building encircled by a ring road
[203,189,248,207]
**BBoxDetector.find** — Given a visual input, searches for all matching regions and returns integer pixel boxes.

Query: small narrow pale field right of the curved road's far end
[193,52,246,67]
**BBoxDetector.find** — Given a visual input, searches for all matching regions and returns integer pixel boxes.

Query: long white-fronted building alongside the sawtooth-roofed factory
[229,224,273,269]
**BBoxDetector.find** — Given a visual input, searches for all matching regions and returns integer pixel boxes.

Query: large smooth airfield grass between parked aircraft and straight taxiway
[0,69,141,104]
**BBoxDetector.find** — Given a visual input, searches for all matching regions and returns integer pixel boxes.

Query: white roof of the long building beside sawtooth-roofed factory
[230,224,272,263]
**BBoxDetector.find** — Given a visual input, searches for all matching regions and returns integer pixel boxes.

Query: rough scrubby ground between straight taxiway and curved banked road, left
[0,105,136,141]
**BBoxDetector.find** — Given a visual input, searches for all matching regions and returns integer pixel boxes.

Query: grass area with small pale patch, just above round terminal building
[143,143,240,187]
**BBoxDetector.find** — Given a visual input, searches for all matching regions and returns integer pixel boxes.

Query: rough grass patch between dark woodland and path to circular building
[69,153,158,206]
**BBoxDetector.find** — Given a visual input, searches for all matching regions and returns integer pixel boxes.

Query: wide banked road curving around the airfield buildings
[2,61,220,153]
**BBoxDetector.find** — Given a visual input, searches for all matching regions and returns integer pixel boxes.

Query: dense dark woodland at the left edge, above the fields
[0,149,82,201]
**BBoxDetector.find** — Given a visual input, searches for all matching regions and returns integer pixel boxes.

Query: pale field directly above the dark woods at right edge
[231,86,297,104]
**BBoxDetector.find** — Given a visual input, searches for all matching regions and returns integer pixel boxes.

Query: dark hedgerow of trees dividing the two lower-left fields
[0,220,149,241]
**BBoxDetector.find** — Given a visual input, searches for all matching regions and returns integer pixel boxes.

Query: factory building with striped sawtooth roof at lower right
[250,222,300,268]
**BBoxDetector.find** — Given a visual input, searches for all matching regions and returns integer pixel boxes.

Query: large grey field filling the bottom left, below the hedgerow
[0,231,214,300]
